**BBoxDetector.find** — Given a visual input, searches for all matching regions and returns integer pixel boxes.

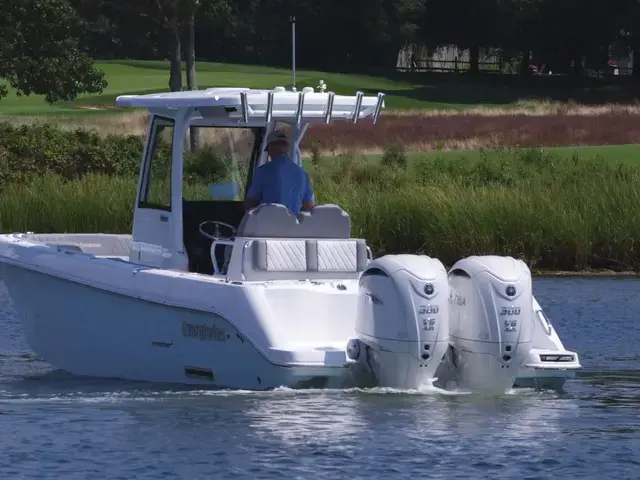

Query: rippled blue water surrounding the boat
[0,279,640,479]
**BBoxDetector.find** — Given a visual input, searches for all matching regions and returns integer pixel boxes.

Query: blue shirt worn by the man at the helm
[247,154,315,216]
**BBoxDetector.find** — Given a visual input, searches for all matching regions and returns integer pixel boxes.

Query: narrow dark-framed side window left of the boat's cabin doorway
[138,118,173,211]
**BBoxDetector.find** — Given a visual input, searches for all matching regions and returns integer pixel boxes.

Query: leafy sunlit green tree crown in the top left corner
[0,0,107,103]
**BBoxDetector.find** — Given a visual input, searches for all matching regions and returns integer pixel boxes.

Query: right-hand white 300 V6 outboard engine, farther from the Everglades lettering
[449,256,533,394]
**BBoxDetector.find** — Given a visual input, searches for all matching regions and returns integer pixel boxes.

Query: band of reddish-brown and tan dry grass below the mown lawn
[5,107,640,156]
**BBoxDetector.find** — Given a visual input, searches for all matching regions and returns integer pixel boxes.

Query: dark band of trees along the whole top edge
[0,0,640,102]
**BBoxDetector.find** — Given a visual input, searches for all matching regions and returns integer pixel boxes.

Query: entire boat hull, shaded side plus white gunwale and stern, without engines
[0,236,573,390]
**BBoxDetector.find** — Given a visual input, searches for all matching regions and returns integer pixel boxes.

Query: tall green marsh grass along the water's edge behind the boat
[0,146,640,271]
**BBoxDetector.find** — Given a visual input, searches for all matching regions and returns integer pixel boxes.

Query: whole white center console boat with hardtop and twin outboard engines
[0,88,580,393]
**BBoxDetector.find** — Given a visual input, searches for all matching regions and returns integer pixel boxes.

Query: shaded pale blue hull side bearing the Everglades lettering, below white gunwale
[2,264,340,390]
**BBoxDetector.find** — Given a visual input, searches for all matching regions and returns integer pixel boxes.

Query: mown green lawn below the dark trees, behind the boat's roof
[0,60,636,115]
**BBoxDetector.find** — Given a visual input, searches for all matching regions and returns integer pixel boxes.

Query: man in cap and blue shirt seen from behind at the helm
[245,130,316,216]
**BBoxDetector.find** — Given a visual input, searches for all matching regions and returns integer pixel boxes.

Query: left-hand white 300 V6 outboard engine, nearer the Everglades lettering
[347,255,449,389]
